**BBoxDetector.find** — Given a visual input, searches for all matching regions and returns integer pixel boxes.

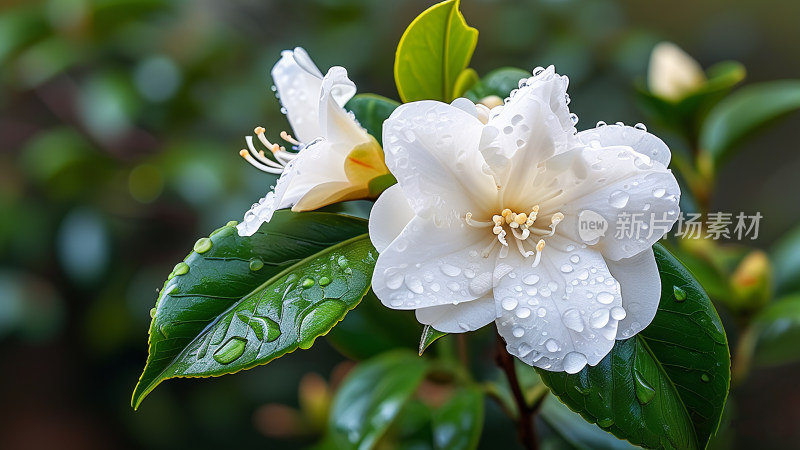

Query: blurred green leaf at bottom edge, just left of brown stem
[433,386,483,450]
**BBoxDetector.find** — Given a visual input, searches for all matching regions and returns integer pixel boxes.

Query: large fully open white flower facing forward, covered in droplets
[369,66,680,373]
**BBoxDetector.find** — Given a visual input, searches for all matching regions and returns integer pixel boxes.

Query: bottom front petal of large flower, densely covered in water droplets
[494,241,622,373]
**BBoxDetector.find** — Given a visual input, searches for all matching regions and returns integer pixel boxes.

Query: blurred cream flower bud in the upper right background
[647,42,706,101]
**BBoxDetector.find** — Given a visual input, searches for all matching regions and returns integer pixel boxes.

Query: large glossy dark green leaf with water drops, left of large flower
[132,211,374,408]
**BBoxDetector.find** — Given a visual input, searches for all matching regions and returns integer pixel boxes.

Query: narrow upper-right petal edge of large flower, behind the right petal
[578,125,672,167]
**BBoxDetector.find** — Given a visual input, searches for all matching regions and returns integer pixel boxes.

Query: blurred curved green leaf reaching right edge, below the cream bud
[700,80,800,164]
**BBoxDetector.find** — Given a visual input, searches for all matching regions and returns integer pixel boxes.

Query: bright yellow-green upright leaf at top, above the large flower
[394,0,478,103]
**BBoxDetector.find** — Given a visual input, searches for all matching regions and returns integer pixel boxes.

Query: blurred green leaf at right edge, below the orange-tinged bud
[752,294,800,365]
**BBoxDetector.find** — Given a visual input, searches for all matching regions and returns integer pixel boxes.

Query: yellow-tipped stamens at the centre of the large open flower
[465,205,564,267]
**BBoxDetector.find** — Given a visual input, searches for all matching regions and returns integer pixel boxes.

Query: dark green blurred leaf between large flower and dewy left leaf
[327,291,419,361]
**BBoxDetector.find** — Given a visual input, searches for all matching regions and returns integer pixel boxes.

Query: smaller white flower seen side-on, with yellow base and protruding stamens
[238,47,388,236]
